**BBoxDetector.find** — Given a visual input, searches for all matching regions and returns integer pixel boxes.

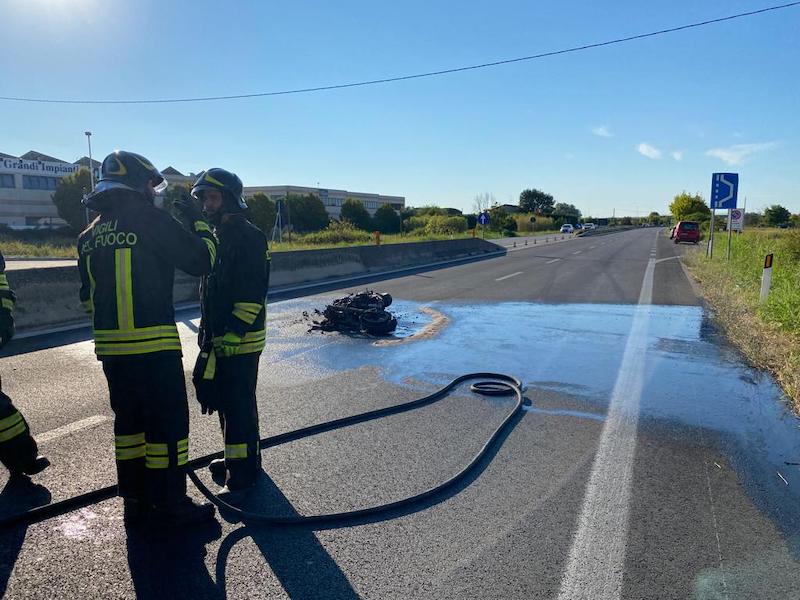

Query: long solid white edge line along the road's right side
[558,236,655,600]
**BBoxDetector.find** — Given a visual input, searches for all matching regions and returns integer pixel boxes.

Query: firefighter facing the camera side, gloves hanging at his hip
[192,169,270,500]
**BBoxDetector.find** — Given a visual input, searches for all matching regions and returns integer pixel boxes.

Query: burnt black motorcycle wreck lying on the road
[310,290,397,335]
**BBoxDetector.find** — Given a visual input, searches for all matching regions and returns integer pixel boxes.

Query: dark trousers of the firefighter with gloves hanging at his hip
[215,352,261,489]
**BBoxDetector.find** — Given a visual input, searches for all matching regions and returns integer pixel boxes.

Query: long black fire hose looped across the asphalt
[0,373,524,528]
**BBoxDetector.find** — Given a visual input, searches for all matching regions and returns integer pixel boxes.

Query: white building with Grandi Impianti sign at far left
[0,150,100,227]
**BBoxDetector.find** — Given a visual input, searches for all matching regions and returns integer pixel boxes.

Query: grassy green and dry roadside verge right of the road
[685,228,800,412]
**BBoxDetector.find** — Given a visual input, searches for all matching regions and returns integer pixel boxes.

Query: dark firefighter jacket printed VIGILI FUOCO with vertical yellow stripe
[78,189,216,359]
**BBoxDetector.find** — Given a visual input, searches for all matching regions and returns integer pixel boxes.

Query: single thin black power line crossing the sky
[0,1,800,104]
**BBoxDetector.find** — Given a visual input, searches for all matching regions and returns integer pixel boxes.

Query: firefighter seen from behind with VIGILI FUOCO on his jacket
[78,150,216,527]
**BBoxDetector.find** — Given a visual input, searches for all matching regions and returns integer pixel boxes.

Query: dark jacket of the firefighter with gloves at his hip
[199,214,270,354]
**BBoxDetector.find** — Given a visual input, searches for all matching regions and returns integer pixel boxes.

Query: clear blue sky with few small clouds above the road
[0,0,800,216]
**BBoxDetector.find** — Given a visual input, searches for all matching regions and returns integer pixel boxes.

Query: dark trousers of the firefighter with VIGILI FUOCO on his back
[103,352,189,505]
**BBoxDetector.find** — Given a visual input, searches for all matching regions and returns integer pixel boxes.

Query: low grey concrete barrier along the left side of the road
[6,239,505,331]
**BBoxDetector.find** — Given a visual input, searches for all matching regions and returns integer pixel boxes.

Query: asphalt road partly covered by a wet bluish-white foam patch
[0,229,800,600]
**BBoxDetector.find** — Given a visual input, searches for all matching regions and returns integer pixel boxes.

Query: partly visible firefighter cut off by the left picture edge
[0,252,50,477]
